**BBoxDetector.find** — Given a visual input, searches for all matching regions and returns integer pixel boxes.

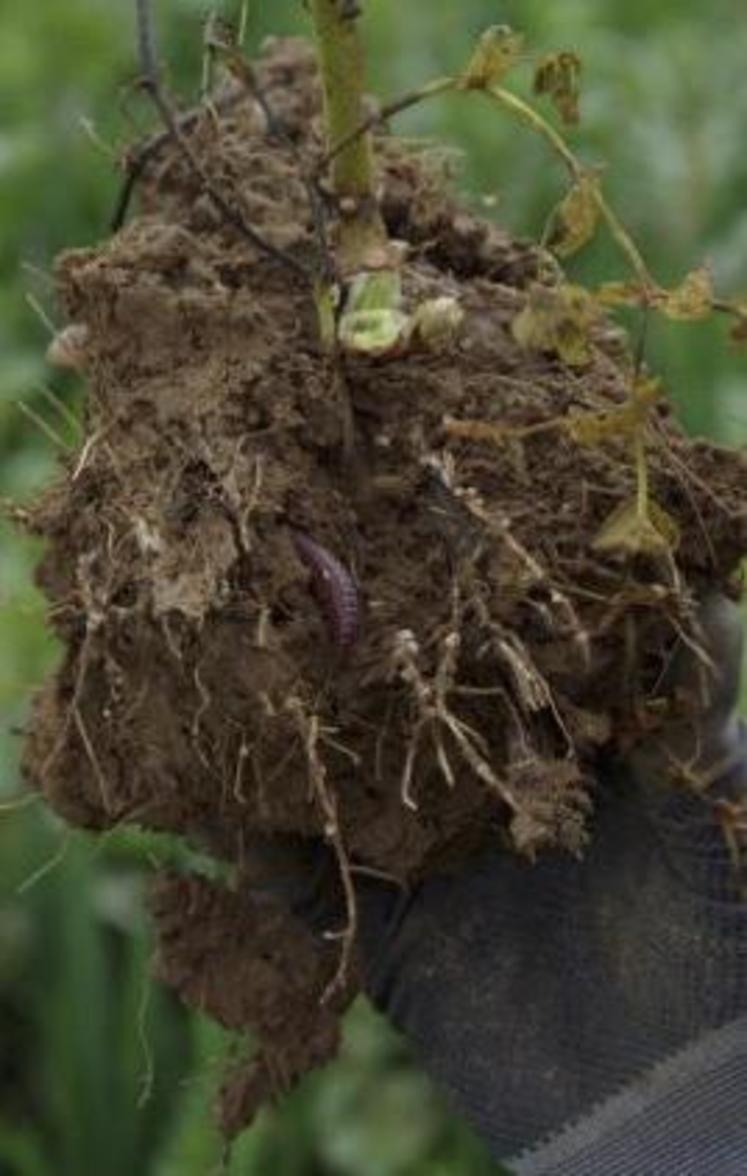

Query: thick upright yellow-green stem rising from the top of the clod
[309,0,387,274]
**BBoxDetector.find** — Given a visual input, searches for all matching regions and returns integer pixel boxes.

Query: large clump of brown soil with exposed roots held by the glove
[20,42,747,1134]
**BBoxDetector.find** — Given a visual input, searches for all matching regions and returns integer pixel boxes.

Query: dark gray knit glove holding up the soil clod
[348,599,747,1176]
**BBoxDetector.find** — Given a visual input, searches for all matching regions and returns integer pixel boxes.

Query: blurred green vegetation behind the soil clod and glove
[0,0,747,1176]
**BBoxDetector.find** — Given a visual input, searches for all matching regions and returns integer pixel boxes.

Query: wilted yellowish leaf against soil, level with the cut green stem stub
[512,283,599,367]
